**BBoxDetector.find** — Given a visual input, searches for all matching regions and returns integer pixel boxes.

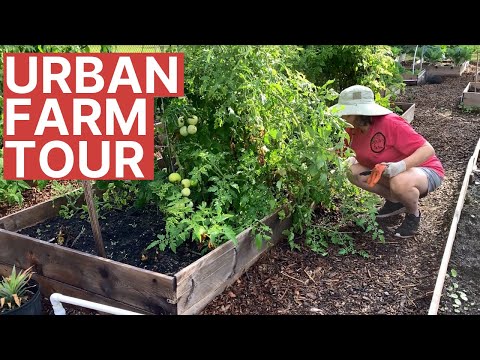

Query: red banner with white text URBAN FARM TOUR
[3,53,184,180]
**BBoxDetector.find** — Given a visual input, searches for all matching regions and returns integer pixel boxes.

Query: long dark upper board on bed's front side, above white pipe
[0,229,176,314]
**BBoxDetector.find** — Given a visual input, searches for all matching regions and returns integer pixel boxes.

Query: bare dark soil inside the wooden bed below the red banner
[19,206,201,275]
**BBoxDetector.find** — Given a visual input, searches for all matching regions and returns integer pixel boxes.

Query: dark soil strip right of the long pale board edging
[438,170,480,315]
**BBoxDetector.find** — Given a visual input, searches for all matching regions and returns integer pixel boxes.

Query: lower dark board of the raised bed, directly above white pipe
[0,263,152,315]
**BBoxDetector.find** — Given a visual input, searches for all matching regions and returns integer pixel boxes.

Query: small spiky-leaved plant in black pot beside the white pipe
[0,265,33,312]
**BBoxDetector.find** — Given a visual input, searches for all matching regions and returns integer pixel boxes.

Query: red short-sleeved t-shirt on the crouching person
[347,113,445,178]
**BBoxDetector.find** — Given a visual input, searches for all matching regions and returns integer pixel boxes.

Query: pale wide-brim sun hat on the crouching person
[330,85,392,116]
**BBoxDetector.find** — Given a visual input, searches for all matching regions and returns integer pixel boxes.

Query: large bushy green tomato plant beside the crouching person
[140,46,386,253]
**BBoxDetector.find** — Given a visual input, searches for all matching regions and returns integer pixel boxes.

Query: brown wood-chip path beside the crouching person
[202,65,480,315]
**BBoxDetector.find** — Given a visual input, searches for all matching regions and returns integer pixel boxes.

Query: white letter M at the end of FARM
[105,99,147,135]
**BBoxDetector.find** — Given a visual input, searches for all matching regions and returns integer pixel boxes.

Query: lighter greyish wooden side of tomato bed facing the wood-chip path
[175,213,291,315]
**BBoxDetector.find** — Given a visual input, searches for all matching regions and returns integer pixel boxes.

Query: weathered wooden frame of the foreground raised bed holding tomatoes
[0,193,291,315]
